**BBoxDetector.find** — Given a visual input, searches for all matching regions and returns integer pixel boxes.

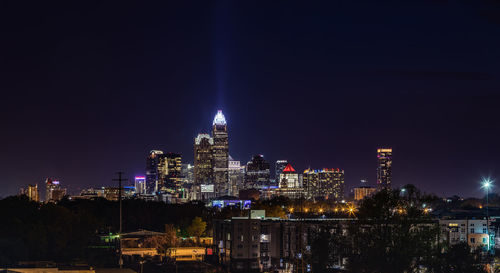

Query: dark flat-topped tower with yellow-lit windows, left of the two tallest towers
[158,153,182,191]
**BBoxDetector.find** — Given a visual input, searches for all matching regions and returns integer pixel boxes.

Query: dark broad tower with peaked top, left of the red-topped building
[245,155,270,189]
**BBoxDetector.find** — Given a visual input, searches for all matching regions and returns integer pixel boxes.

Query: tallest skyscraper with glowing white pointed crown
[212,110,229,196]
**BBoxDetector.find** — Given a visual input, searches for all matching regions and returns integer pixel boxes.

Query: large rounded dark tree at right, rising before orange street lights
[345,188,439,273]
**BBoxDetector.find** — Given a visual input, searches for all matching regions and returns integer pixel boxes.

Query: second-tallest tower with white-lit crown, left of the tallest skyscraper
[194,134,214,186]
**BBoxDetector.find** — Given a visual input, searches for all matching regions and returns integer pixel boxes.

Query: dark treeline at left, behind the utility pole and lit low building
[0,196,207,265]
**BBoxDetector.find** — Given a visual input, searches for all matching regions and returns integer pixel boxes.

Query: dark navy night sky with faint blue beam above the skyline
[0,0,500,196]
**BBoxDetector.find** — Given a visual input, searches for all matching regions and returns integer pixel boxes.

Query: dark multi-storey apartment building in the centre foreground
[213,214,351,272]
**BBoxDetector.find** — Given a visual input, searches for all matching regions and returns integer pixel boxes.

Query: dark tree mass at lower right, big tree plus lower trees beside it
[309,185,487,273]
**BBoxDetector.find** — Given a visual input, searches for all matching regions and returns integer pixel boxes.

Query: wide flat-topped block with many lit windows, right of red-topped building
[303,168,344,200]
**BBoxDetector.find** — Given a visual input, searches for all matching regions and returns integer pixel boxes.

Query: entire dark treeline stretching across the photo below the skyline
[0,185,492,273]
